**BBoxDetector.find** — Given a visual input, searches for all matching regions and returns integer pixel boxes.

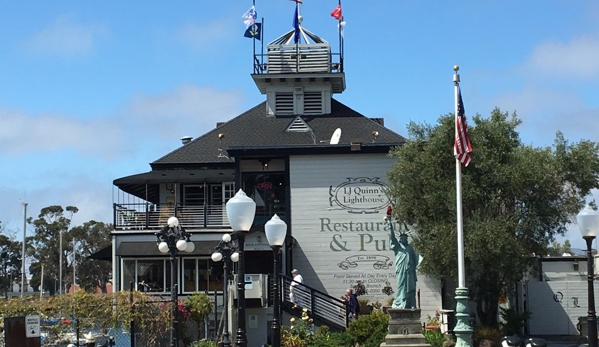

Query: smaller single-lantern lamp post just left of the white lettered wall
[264,214,287,347]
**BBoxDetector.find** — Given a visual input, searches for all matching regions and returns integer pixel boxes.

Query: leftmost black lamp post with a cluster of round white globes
[156,217,195,347]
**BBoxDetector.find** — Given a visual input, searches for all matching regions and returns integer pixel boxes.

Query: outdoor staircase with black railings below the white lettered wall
[280,275,349,331]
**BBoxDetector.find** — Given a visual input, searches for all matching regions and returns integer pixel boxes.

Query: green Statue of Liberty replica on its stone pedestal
[381,206,428,347]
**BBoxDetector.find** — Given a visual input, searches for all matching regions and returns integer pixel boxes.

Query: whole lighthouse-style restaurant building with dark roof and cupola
[112,4,441,346]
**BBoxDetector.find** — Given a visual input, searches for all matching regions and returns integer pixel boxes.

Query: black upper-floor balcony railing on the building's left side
[114,203,285,230]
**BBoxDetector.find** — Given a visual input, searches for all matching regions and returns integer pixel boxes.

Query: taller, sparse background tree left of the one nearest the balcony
[27,205,79,295]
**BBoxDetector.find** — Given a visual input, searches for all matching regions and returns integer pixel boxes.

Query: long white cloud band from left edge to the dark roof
[0,85,241,159]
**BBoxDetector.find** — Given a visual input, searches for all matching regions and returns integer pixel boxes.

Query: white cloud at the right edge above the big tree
[525,36,599,79]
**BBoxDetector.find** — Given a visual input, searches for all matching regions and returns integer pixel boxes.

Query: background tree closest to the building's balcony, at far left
[69,220,113,293]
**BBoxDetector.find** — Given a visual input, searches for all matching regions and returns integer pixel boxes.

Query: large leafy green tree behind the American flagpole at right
[389,108,599,326]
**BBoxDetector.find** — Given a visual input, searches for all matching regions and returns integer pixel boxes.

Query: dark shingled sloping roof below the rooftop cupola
[151,99,406,170]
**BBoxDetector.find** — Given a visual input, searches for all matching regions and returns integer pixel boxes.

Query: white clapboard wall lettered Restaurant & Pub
[289,154,441,317]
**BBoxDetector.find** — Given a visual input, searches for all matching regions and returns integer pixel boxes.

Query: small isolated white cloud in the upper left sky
[24,15,108,57]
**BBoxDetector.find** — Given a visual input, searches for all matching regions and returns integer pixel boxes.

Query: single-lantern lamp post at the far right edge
[576,205,599,347]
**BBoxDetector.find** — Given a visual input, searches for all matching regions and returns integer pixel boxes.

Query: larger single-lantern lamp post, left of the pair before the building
[226,189,256,347]
